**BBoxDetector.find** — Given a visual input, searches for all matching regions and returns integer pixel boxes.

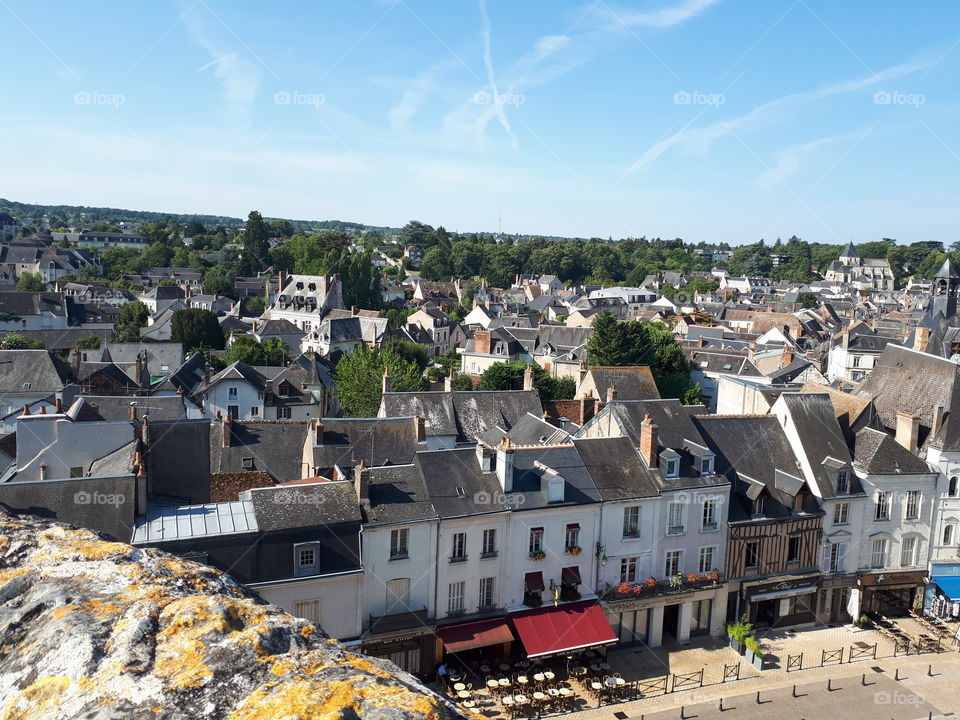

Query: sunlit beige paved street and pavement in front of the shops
[454,624,960,720]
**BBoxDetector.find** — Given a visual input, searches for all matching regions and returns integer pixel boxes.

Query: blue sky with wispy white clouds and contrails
[0,0,960,245]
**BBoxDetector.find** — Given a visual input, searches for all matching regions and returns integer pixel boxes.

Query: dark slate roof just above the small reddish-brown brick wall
[210,420,308,483]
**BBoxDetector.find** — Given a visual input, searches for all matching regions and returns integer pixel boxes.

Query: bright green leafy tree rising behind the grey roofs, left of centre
[333,345,424,417]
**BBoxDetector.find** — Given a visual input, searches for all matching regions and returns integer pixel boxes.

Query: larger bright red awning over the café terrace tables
[510,600,617,657]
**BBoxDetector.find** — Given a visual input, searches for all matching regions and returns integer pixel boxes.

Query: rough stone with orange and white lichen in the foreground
[0,514,459,720]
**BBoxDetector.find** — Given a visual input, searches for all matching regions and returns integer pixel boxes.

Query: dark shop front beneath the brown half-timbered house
[741,573,821,627]
